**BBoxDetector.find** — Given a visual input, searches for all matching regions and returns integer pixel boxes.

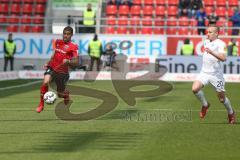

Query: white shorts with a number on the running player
[197,72,225,92]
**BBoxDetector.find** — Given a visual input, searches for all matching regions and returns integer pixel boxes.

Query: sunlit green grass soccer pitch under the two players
[0,80,240,160]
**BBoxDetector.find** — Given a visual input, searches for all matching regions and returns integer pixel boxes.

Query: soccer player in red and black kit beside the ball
[36,26,78,113]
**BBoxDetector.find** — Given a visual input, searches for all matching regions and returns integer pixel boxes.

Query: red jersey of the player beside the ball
[48,39,78,73]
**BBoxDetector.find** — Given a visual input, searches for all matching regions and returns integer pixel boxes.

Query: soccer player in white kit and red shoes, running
[192,25,235,124]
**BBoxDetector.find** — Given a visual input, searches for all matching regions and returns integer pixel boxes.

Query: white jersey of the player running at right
[202,39,226,74]
